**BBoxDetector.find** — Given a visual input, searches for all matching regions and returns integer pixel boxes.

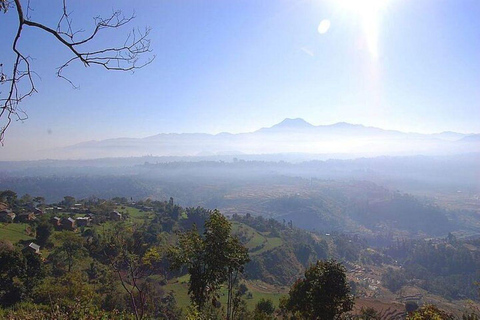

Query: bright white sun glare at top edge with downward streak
[336,0,387,59]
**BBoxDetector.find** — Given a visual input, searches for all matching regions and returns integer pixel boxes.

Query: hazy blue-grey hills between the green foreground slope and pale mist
[0,170,480,237]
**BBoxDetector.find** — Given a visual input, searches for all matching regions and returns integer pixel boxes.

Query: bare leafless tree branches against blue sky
[0,0,154,144]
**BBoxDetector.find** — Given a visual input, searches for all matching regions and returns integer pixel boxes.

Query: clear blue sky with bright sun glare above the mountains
[0,0,480,160]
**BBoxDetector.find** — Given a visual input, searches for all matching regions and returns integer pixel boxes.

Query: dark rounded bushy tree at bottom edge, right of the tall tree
[282,260,353,320]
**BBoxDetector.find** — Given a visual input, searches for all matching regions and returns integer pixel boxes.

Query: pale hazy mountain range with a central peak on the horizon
[39,118,480,159]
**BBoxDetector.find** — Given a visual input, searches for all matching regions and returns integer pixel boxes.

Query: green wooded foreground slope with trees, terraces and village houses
[0,190,480,319]
